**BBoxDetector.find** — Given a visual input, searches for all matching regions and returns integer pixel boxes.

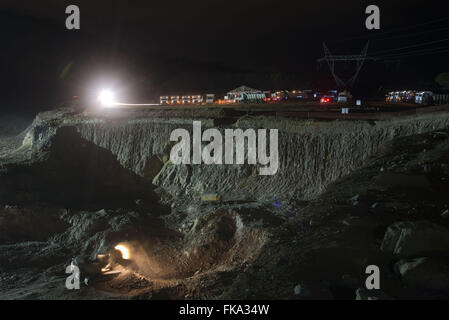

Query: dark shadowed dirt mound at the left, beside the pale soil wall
[0,127,161,209]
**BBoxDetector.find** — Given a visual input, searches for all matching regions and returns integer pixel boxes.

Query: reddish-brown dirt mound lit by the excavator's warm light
[128,211,266,279]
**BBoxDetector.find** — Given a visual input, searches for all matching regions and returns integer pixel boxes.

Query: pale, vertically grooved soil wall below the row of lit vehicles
[68,113,449,200]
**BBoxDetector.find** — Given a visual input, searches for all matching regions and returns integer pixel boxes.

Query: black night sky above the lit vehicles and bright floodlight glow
[0,0,449,110]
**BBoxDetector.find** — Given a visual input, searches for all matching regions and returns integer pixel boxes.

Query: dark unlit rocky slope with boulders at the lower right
[224,131,449,299]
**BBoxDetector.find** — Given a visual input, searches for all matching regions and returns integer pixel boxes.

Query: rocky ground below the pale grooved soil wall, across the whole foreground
[0,110,449,299]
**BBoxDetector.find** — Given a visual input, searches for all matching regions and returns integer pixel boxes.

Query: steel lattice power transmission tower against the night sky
[318,41,374,89]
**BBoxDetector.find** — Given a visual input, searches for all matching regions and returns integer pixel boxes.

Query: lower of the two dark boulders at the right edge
[395,258,449,292]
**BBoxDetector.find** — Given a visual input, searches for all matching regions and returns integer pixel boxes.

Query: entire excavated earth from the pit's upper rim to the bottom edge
[0,110,449,299]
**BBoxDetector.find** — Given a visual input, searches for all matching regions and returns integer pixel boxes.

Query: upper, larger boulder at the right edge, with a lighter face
[381,221,449,258]
